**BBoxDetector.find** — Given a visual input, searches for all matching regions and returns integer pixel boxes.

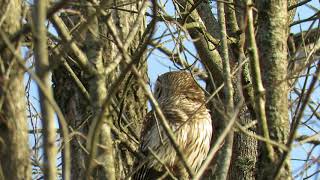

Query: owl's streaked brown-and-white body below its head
[136,102,212,178]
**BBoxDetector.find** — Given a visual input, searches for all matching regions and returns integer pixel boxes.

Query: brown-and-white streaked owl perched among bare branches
[133,71,212,180]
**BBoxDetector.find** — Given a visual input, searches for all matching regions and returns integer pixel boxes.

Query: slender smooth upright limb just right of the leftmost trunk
[33,0,57,180]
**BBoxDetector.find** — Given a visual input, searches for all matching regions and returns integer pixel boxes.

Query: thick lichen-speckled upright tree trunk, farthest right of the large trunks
[257,0,291,179]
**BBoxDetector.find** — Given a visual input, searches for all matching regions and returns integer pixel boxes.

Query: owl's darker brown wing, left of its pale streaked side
[134,107,188,180]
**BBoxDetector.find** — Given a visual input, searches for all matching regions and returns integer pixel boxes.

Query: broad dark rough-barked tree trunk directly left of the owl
[53,1,147,179]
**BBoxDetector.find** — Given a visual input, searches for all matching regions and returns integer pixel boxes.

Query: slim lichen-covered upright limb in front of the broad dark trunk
[84,1,116,180]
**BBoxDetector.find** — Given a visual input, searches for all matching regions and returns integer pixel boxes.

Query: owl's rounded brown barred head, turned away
[154,71,205,102]
